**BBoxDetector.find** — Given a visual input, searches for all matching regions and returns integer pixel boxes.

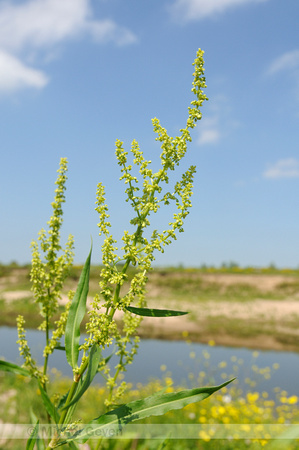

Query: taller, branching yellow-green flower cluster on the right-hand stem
[82,49,207,404]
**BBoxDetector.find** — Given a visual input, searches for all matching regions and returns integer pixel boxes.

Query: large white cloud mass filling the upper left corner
[0,0,137,91]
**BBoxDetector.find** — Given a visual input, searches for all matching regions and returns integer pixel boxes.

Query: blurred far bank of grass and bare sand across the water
[0,265,299,350]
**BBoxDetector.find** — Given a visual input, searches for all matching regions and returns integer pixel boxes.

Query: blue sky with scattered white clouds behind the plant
[0,0,299,267]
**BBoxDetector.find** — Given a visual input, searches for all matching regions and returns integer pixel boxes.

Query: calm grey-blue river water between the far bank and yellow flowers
[0,327,299,397]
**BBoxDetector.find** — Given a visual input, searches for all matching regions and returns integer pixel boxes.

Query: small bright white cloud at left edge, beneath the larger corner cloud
[0,50,48,92]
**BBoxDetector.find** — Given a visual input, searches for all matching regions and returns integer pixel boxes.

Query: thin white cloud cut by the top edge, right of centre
[170,0,267,22]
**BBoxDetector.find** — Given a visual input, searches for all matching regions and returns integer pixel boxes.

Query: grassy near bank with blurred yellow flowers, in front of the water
[0,361,299,450]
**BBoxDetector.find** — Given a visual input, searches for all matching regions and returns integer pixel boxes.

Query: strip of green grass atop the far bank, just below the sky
[0,265,299,301]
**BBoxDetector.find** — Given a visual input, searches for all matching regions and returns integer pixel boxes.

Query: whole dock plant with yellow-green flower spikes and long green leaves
[0,49,231,450]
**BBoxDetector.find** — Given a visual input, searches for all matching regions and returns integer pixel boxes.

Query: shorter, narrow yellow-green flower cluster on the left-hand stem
[17,158,74,385]
